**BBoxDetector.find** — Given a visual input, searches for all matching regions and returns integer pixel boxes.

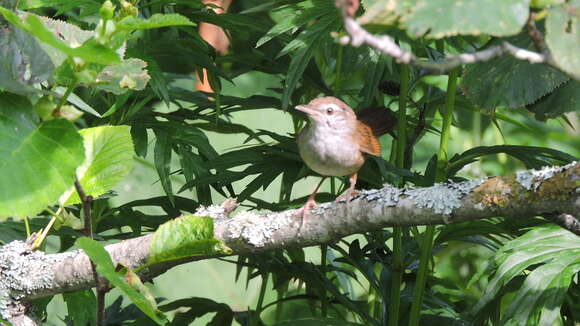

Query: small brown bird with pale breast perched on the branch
[296,97,397,216]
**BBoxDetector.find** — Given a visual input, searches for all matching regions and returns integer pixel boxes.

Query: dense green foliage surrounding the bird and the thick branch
[0,0,580,326]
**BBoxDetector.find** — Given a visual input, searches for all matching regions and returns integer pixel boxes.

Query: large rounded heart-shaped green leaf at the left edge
[0,93,84,217]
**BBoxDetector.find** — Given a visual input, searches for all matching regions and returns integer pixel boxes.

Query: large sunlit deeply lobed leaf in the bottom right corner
[473,224,580,325]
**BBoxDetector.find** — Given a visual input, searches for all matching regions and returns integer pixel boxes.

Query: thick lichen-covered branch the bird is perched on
[0,162,580,325]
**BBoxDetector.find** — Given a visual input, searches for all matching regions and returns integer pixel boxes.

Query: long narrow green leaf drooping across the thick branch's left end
[75,237,168,325]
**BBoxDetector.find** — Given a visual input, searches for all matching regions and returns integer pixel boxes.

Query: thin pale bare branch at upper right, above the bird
[339,16,553,73]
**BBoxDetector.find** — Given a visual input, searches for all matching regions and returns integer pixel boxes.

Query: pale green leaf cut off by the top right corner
[546,0,580,81]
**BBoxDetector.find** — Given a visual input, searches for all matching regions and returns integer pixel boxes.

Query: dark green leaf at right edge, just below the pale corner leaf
[528,80,580,120]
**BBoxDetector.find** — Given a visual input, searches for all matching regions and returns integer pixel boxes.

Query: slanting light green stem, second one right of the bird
[409,68,459,326]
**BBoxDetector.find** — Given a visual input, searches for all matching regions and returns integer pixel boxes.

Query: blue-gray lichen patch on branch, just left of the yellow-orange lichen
[404,179,485,215]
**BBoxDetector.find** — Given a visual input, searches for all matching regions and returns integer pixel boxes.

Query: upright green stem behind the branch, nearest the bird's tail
[389,65,411,326]
